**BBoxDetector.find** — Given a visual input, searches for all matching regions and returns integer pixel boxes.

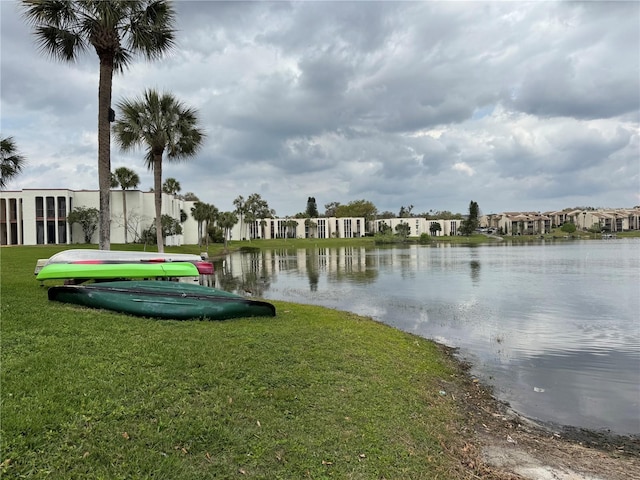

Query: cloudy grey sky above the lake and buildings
[0,0,640,216]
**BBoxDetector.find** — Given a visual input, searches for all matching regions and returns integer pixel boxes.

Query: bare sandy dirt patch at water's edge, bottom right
[442,346,640,480]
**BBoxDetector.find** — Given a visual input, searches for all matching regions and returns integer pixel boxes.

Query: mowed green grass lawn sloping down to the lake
[0,247,471,479]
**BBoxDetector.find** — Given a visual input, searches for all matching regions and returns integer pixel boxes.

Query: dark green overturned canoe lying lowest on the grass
[48,280,276,320]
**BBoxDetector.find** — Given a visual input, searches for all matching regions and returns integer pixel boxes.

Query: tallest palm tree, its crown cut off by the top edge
[22,0,175,250]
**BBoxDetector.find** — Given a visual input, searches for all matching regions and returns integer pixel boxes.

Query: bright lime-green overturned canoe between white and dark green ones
[36,262,200,280]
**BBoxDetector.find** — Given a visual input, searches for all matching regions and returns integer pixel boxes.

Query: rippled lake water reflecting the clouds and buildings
[211,239,640,435]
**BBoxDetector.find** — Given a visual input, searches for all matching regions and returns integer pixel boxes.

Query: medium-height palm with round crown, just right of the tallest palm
[113,89,204,252]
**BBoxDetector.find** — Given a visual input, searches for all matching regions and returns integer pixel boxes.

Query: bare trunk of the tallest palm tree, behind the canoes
[98,55,113,250]
